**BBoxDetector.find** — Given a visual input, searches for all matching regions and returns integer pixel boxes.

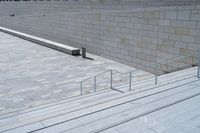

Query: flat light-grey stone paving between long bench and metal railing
[0,33,151,111]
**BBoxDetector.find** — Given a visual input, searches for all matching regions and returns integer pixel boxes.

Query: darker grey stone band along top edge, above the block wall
[0,0,200,16]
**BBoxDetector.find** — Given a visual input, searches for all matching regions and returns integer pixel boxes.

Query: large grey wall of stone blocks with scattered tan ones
[0,0,200,73]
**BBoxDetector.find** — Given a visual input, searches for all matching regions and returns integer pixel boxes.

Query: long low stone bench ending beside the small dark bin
[0,27,80,55]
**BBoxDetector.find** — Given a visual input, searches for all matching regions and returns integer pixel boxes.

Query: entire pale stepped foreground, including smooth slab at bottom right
[0,67,197,133]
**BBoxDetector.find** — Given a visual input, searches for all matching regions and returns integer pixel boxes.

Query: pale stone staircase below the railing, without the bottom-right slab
[0,67,200,133]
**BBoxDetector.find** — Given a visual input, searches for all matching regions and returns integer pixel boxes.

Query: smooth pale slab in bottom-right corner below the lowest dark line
[100,92,200,133]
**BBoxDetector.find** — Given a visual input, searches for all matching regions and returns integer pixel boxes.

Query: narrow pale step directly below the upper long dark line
[29,77,200,133]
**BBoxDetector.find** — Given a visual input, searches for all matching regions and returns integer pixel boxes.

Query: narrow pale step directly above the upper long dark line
[1,74,196,130]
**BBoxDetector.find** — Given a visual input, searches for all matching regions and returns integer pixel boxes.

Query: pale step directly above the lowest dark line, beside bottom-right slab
[62,84,200,133]
